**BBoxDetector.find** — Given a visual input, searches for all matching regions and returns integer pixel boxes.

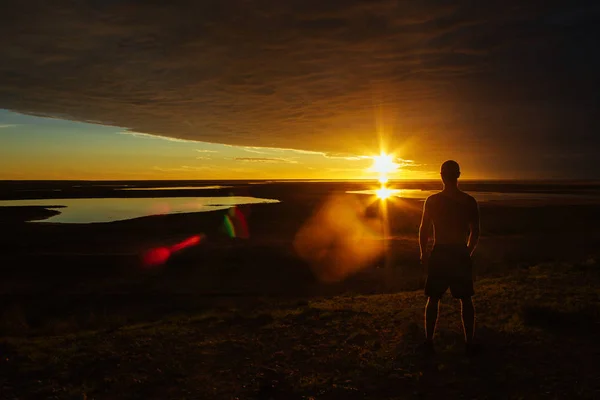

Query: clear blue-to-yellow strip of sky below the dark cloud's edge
[0,110,412,180]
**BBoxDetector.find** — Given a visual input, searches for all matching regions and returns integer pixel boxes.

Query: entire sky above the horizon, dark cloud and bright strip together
[0,0,600,179]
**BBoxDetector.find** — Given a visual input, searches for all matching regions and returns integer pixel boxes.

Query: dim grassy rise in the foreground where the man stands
[0,260,600,399]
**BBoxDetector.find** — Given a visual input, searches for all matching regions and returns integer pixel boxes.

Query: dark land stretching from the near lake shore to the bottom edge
[0,186,600,399]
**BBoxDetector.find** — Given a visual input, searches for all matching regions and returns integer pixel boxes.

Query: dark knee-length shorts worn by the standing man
[425,245,475,299]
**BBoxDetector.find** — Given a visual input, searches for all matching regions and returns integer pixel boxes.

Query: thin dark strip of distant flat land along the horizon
[0,181,600,200]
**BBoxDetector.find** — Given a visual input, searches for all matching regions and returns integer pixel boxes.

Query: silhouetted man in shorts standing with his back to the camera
[419,160,479,355]
